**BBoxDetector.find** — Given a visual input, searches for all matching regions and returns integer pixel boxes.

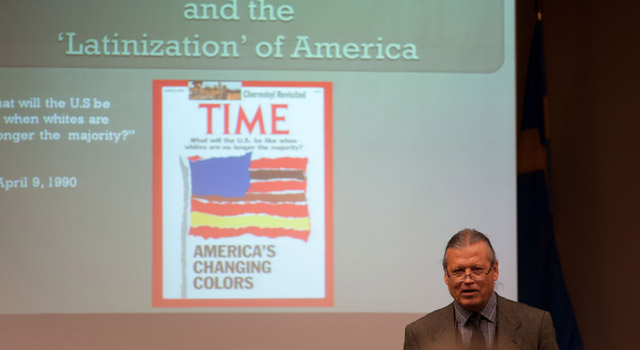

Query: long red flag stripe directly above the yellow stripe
[191,200,309,218]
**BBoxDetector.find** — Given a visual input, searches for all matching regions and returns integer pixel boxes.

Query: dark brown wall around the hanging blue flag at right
[516,0,640,350]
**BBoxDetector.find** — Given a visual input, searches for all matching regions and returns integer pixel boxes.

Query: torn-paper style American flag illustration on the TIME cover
[189,153,310,242]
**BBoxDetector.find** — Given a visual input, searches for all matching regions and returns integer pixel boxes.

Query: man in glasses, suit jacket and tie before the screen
[404,229,558,350]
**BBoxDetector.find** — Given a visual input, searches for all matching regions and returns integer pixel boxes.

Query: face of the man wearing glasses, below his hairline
[444,242,498,311]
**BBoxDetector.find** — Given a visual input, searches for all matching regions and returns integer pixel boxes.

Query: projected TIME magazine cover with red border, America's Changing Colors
[153,80,333,306]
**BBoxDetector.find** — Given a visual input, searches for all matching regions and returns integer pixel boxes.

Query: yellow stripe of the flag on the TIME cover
[191,212,310,231]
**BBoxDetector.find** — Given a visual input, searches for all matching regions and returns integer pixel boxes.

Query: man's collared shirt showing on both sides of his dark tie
[453,292,498,349]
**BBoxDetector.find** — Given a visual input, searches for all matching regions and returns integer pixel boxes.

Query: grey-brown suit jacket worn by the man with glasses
[404,295,558,350]
